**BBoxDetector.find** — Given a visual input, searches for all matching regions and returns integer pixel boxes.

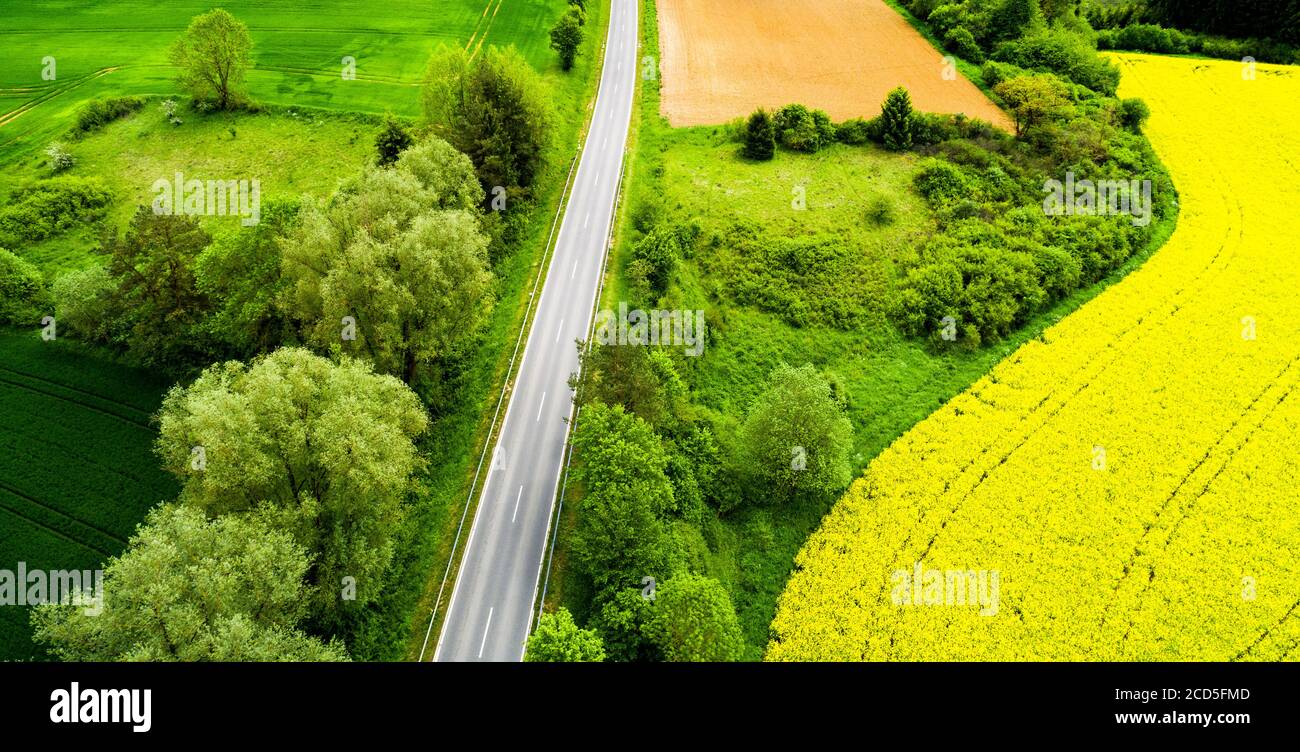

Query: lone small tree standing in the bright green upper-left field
[170,8,252,109]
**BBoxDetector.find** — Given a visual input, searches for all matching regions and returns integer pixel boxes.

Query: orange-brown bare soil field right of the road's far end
[658,0,1011,130]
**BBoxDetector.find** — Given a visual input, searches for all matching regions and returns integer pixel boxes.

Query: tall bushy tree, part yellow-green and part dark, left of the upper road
[423,47,551,196]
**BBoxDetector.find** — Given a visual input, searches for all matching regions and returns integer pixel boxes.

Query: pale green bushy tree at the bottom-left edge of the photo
[33,505,347,661]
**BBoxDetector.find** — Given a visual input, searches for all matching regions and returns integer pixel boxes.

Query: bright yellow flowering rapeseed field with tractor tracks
[767,55,1300,661]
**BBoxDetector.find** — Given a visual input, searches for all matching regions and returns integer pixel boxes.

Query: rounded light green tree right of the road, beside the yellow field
[740,364,853,497]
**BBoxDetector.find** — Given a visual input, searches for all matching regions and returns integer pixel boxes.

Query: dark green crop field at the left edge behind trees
[0,329,178,660]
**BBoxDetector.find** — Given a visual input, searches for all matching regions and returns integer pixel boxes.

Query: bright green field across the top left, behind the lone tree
[0,0,566,164]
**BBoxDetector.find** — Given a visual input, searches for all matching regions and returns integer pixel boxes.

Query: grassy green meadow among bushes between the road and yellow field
[547,0,1174,660]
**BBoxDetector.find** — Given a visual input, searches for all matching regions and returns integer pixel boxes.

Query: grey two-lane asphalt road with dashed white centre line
[433,0,638,661]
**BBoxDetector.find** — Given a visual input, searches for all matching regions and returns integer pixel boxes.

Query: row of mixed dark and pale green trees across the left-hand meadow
[53,138,494,392]
